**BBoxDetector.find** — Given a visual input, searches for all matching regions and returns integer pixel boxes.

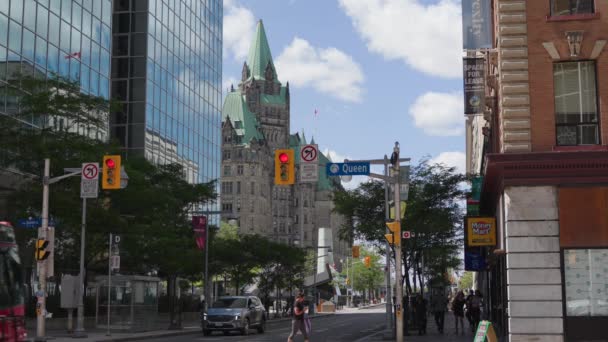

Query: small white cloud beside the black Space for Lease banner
[409,92,464,136]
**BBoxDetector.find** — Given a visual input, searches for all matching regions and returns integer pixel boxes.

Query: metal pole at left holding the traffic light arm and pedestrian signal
[36,158,51,341]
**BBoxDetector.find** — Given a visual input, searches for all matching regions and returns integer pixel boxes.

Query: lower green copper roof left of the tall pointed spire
[222,91,264,144]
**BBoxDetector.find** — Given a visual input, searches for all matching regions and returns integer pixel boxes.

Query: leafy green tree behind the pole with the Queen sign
[334,159,466,292]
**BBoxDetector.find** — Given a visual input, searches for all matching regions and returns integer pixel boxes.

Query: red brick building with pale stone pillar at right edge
[467,0,608,341]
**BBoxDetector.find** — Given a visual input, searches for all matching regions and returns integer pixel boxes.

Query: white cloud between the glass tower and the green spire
[223,0,256,61]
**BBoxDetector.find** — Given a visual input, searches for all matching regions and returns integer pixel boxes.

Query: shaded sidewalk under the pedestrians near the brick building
[357,311,474,342]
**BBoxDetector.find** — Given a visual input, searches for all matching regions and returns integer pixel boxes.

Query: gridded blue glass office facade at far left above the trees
[0,0,112,133]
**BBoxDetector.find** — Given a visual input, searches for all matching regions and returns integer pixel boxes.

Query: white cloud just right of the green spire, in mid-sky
[275,37,364,102]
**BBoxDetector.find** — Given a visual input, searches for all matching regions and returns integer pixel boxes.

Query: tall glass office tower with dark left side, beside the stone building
[111,0,222,183]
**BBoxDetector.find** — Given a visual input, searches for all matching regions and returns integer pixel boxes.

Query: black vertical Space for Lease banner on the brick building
[462,57,486,114]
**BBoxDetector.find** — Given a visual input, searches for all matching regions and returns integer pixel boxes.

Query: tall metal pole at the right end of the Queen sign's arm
[393,142,403,342]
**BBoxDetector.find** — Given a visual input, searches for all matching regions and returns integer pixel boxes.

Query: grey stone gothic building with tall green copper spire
[221,21,350,260]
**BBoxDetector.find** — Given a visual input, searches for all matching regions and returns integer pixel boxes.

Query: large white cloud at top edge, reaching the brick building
[339,0,462,78]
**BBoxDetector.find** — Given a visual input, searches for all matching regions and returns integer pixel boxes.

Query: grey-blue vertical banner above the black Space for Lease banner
[462,0,492,50]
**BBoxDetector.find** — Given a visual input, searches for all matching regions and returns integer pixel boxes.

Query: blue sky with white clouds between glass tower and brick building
[223,0,465,188]
